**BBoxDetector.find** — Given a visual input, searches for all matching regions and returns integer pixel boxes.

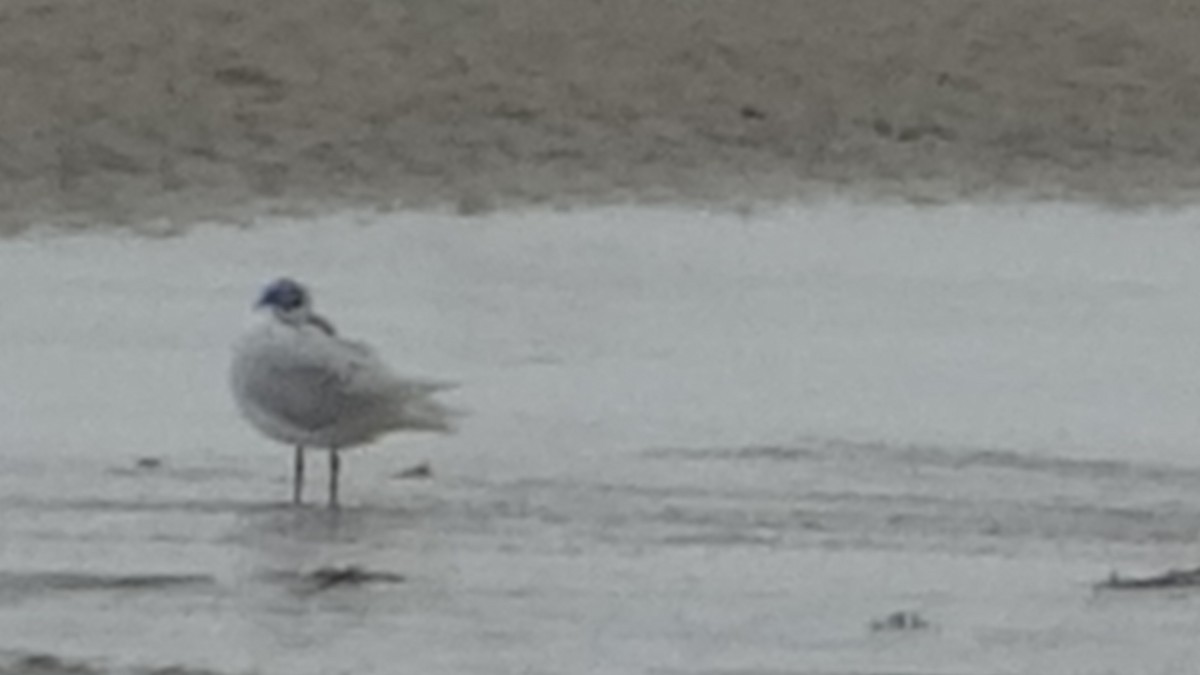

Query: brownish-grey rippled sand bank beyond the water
[0,0,1200,231]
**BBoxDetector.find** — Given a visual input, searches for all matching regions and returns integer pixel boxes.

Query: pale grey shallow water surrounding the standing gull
[0,204,1200,674]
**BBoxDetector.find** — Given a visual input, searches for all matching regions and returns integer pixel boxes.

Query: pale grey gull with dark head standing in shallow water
[230,279,456,508]
